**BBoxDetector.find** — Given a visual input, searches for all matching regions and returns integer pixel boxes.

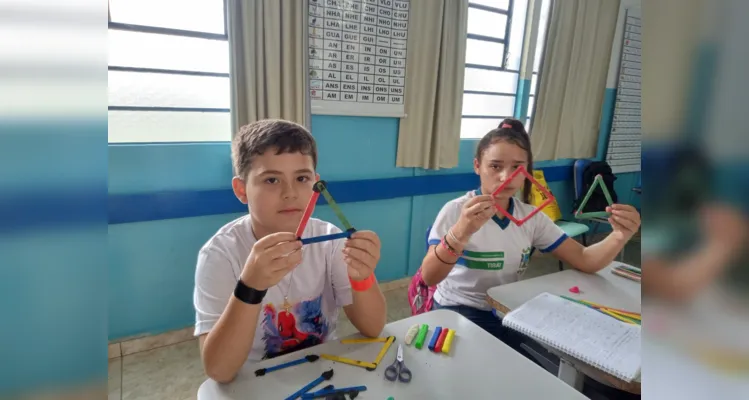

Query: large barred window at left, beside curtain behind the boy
[108,0,231,143]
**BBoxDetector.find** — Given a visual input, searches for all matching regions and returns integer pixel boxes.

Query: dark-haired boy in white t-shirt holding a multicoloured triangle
[194,120,386,383]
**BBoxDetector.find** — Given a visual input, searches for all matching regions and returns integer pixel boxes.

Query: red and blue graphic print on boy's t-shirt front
[262,295,329,359]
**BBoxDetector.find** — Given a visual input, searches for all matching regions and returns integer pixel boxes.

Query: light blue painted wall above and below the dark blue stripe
[109,116,636,339]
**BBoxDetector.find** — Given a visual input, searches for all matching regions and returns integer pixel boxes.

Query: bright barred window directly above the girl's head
[460,0,550,139]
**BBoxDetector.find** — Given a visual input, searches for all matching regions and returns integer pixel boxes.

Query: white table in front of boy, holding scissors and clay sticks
[198,310,586,400]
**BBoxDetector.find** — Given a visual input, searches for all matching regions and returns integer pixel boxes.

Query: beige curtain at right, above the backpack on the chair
[531,0,619,160]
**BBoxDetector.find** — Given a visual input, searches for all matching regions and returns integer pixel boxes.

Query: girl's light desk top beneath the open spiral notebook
[487,261,641,394]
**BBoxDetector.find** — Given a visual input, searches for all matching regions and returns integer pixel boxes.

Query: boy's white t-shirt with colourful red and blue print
[193,215,353,361]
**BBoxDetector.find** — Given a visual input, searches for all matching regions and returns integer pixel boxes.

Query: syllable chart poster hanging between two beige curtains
[308,0,410,117]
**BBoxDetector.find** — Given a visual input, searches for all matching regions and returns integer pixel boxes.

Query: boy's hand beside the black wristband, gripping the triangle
[240,232,302,290]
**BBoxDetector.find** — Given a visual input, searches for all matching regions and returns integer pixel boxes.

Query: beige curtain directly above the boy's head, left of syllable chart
[227,0,310,135]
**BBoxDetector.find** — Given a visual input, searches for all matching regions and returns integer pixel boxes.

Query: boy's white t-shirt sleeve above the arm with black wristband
[193,248,239,336]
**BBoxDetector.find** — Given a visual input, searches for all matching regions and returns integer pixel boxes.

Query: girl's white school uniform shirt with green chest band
[429,190,567,311]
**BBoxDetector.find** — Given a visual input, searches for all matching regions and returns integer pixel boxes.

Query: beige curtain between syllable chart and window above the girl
[396,0,468,169]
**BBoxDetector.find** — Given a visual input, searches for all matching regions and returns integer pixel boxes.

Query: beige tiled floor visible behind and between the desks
[109,236,640,400]
